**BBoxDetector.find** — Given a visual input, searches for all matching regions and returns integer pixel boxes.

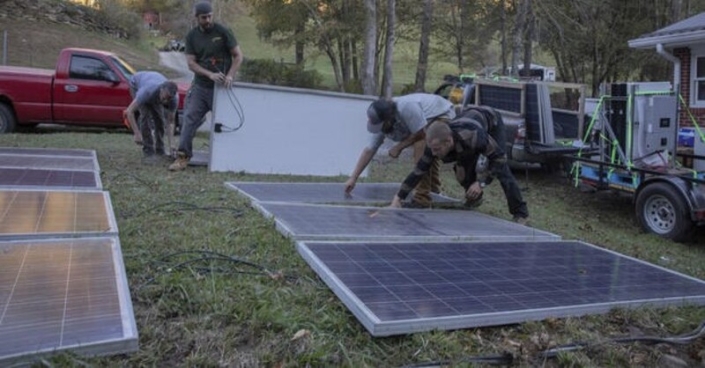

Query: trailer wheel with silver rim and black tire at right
[636,183,694,242]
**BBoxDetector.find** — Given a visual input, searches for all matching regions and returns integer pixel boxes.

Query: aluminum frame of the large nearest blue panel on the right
[296,241,705,337]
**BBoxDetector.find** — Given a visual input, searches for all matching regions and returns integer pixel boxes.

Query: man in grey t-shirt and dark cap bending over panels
[345,93,455,207]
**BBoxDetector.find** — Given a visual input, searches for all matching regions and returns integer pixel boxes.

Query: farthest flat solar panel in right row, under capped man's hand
[225,182,457,204]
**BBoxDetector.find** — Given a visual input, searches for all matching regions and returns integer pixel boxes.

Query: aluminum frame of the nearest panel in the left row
[0,236,139,366]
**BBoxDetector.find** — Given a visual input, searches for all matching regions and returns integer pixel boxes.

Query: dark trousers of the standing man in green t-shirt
[178,84,213,159]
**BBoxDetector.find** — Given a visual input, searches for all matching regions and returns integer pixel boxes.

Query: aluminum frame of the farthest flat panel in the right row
[225,181,459,205]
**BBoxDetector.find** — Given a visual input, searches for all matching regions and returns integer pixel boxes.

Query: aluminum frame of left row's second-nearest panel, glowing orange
[0,188,118,241]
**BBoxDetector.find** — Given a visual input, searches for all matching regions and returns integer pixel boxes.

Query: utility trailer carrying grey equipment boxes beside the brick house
[570,83,705,241]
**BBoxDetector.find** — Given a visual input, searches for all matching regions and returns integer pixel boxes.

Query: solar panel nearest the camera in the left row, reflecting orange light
[0,238,138,366]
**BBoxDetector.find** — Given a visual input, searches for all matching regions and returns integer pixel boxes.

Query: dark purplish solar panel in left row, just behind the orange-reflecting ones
[0,167,102,189]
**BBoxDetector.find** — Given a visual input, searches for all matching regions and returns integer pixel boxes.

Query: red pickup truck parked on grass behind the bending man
[0,48,189,133]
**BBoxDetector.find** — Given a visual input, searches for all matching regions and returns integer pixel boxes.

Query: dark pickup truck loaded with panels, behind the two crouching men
[434,78,590,167]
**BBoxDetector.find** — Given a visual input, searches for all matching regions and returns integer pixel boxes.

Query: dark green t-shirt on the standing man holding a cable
[185,23,237,88]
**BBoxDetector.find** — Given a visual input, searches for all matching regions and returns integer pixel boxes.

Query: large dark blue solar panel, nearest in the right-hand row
[297,241,705,336]
